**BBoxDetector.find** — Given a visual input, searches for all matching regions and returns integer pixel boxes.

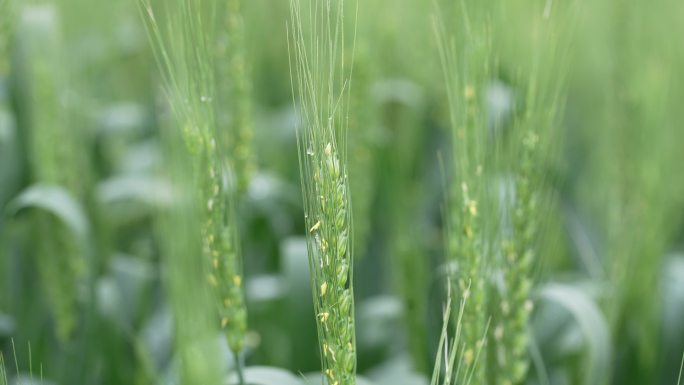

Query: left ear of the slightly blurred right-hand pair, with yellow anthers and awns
[434,4,498,385]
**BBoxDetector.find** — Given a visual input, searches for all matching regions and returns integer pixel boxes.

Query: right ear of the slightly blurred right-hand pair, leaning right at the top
[490,9,565,385]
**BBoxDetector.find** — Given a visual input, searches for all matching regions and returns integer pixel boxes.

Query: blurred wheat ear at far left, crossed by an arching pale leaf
[20,5,88,342]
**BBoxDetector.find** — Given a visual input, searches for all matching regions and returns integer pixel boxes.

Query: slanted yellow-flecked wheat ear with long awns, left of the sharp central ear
[139,0,247,354]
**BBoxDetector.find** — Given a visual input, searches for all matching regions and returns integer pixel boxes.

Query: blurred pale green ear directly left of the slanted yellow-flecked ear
[157,127,222,384]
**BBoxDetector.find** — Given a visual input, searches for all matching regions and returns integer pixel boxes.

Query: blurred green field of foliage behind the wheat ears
[0,0,684,385]
